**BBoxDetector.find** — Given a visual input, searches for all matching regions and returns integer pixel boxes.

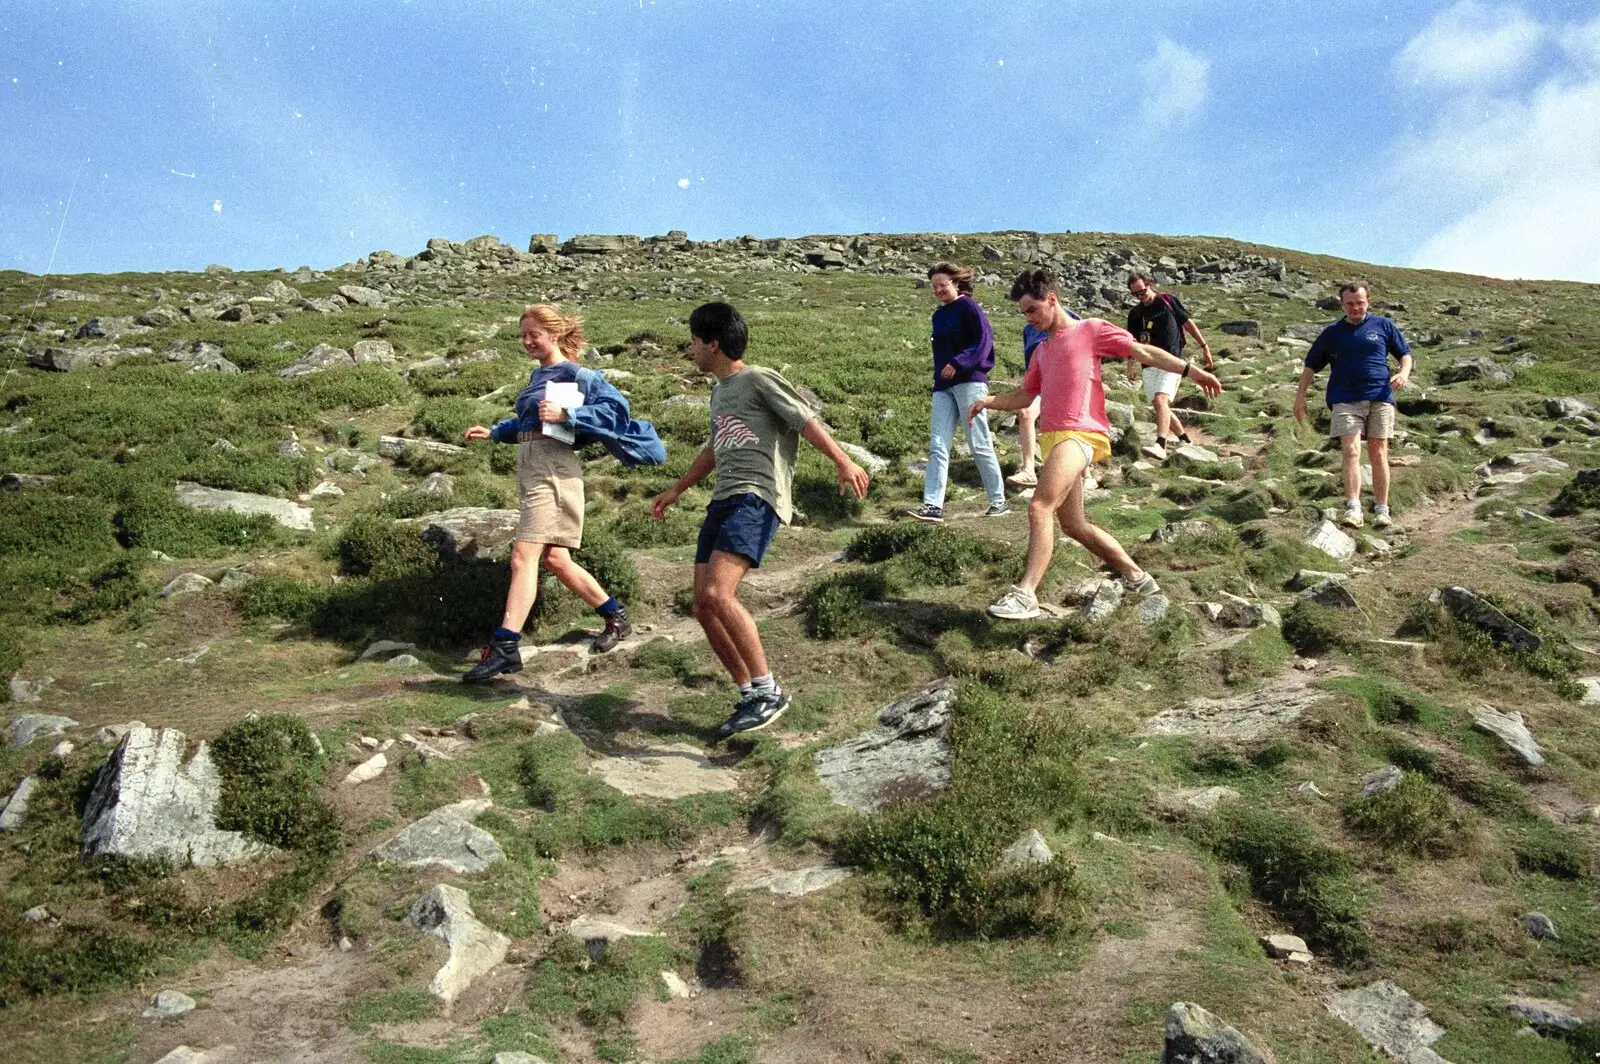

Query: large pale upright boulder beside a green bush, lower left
[78,726,275,866]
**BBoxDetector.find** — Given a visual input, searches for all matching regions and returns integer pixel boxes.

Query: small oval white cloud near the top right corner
[1395,0,1544,88]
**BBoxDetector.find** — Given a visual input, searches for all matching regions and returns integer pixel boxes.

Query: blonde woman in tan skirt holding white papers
[461,302,643,683]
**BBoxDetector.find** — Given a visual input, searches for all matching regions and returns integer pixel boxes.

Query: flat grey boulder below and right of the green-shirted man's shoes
[813,680,955,813]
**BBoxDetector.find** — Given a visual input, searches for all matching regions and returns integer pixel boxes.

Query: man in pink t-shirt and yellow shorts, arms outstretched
[966,269,1222,621]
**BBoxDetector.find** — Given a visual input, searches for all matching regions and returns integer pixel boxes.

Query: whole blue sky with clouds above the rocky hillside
[0,0,1600,282]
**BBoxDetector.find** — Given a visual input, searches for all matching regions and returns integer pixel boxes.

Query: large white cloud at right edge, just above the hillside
[1402,19,1600,282]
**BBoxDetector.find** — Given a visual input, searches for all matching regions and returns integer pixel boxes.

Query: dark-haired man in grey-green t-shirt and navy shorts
[650,302,867,739]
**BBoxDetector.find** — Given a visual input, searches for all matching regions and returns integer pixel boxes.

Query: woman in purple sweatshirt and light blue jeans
[906,262,1011,522]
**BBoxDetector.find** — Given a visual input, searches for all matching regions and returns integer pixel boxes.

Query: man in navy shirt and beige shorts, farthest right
[1294,282,1411,528]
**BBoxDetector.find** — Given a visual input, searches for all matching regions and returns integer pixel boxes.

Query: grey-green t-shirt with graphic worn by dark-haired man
[706,366,816,525]
